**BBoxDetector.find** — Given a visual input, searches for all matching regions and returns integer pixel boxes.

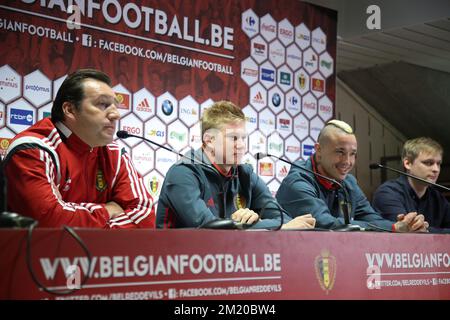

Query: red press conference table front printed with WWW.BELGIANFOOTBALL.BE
[0,229,450,300]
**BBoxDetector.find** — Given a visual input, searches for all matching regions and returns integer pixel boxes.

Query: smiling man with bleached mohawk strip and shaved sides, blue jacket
[276,120,427,232]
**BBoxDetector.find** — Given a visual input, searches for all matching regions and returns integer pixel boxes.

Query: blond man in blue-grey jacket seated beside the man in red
[156,101,315,229]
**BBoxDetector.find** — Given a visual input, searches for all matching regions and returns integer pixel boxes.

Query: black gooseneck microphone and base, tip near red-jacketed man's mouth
[116,130,251,230]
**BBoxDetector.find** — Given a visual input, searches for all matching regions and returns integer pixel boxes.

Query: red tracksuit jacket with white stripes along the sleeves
[5,118,155,228]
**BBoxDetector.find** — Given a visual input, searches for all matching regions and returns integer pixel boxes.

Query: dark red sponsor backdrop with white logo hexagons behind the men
[0,0,337,199]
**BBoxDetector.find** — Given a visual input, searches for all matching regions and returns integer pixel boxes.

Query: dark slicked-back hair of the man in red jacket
[52,69,111,122]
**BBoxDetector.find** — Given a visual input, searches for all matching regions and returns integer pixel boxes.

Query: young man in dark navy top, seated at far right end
[373,137,450,233]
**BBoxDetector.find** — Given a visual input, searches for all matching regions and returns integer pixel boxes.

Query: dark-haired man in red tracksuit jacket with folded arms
[4,69,155,228]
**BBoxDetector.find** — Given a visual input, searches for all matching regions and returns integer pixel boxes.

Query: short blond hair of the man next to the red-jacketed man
[201,100,245,137]
